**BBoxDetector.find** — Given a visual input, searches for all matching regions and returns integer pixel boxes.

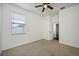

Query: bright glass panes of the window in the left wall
[12,14,25,33]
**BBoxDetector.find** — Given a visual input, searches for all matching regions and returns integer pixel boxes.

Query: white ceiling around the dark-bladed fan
[14,3,78,16]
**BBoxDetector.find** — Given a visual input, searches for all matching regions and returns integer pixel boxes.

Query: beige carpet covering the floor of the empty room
[2,39,79,56]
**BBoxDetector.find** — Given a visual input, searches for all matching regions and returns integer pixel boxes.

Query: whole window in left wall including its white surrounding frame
[11,12,26,34]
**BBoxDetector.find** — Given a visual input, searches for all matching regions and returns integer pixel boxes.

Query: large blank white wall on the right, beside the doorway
[59,5,79,48]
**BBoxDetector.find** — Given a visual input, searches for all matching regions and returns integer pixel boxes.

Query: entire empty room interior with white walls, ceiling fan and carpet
[0,3,79,56]
